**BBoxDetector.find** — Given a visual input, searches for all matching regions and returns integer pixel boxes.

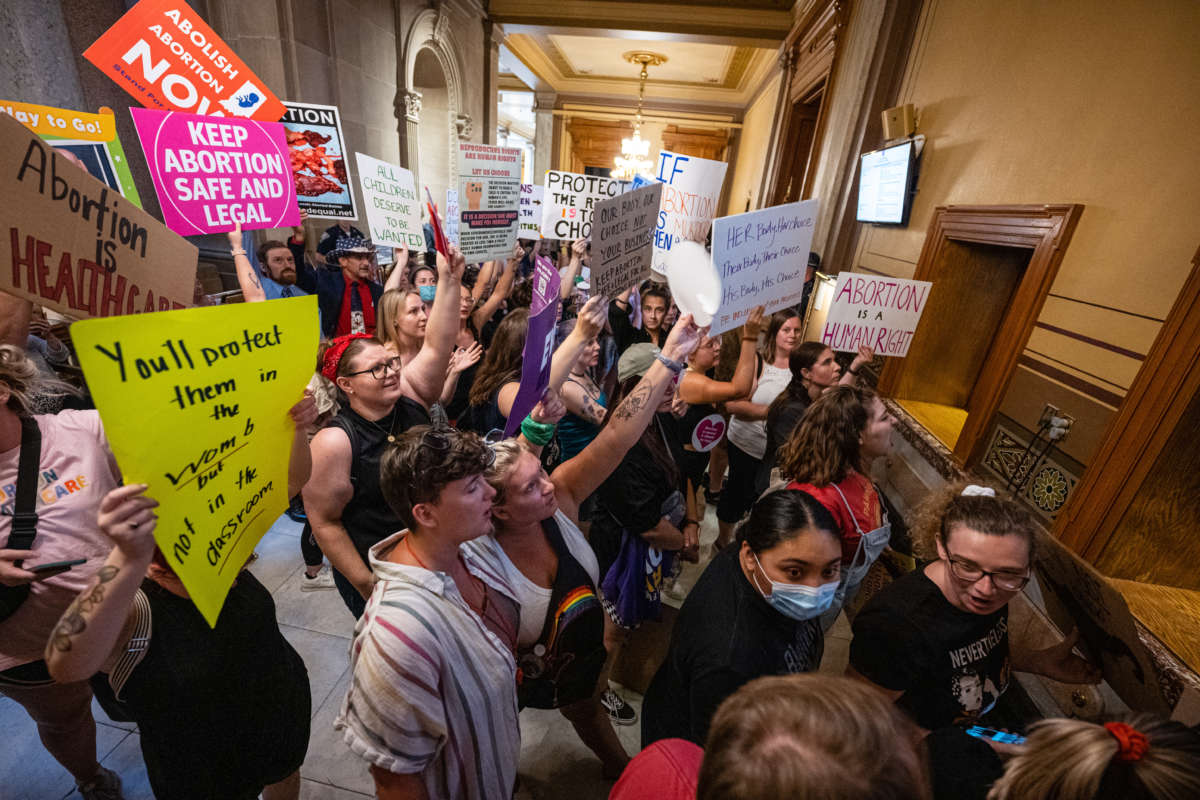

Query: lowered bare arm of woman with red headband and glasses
[302,427,372,597]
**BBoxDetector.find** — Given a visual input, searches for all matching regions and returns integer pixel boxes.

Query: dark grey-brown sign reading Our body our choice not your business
[592,184,662,297]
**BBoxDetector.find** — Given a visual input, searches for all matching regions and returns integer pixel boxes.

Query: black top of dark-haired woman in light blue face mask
[642,547,824,747]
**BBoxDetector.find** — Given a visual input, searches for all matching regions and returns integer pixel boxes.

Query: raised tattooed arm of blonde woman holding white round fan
[551,314,703,509]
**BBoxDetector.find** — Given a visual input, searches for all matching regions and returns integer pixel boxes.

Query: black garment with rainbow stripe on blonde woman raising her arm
[517,517,607,709]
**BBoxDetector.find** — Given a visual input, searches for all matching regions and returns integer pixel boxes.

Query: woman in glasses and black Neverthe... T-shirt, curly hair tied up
[847,485,1100,730]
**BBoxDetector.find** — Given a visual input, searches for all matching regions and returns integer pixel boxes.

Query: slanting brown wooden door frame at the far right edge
[1051,249,1200,561]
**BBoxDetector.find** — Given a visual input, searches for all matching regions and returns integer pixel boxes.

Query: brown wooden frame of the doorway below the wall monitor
[878,203,1084,465]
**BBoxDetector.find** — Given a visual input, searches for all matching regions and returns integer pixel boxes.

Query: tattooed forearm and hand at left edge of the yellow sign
[46,483,158,682]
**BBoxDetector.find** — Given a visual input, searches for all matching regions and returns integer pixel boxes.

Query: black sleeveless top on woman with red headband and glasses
[325,396,430,564]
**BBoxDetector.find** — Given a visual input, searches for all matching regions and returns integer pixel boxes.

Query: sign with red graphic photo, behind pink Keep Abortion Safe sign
[281,103,359,219]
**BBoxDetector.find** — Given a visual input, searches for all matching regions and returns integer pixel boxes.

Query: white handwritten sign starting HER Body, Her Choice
[709,199,817,336]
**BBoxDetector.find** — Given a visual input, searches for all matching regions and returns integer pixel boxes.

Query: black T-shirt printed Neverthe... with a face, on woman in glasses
[850,569,1012,730]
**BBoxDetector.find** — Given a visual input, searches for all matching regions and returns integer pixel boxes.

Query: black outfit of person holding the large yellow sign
[112,571,312,800]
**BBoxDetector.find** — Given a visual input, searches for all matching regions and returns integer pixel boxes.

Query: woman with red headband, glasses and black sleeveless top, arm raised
[304,245,467,618]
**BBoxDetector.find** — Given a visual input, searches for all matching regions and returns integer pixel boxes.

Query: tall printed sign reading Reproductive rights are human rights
[458,142,523,264]
